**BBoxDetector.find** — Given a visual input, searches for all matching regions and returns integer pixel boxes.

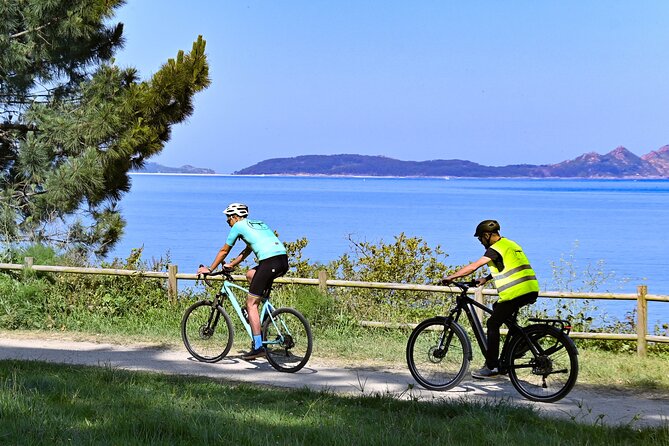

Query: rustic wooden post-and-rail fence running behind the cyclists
[0,257,669,356]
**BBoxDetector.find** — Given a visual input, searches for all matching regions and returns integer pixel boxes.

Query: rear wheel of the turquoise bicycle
[262,308,314,373]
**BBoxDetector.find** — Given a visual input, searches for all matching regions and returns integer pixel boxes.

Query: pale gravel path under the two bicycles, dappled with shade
[0,333,669,427]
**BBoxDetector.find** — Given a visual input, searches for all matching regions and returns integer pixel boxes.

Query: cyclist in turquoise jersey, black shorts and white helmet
[197,203,288,360]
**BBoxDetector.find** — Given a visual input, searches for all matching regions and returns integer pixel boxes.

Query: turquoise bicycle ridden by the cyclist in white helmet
[181,270,313,373]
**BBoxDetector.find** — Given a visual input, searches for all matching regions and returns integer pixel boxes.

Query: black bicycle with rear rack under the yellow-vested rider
[406,281,578,403]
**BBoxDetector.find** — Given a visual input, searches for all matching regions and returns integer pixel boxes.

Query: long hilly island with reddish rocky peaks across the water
[233,145,669,178]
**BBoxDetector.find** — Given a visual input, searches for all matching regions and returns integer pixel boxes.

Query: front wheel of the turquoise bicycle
[181,300,235,362]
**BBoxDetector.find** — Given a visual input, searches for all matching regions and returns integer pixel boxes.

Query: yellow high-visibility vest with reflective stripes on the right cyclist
[488,238,539,302]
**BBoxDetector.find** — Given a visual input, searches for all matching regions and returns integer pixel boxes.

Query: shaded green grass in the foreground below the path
[0,361,669,446]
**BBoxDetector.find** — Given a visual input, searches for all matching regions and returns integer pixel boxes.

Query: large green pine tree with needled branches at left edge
[0,0,209,256]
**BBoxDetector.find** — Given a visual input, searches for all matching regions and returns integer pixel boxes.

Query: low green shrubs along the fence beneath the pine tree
[0,246,173,331]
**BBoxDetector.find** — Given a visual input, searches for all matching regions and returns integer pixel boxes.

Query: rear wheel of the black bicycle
[508,324,578,403]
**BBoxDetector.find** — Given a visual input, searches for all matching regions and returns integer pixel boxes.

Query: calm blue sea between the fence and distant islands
[112,174,669,327]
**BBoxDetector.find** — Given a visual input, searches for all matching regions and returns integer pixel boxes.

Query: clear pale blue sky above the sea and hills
[115,0,669,173]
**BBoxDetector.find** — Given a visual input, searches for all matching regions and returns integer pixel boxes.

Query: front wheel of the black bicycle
[406,317,472,390]
